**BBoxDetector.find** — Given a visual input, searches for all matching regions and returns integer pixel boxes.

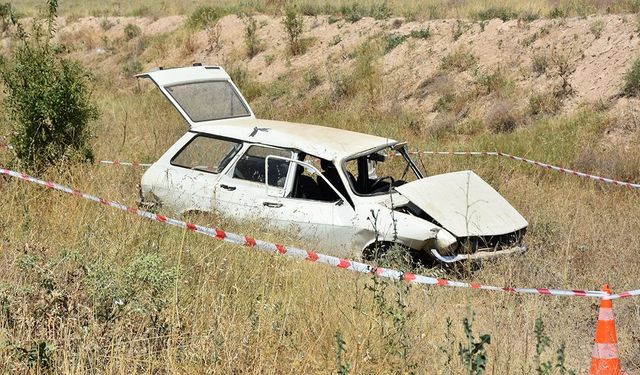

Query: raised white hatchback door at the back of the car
[136,66,255,129]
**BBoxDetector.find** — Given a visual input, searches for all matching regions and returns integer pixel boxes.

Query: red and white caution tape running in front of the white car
[0,168,640,299]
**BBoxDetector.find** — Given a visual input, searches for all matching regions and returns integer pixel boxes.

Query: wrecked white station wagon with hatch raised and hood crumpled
[138,66,528,262]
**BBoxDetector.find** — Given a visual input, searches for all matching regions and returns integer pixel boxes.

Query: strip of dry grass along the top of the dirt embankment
[8,0,640,21]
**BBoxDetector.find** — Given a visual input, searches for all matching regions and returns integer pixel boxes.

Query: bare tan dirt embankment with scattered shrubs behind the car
[23,15,640,143]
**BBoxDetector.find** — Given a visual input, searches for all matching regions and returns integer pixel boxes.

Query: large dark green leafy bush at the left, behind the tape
[0,0,98,170]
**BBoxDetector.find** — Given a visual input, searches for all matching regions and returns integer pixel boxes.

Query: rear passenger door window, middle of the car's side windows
[233,146,293,188]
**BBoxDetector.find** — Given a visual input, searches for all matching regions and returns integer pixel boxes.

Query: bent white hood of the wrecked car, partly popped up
[396,171,528,237]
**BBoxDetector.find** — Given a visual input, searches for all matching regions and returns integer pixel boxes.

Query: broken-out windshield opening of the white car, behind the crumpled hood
[344,145,423,195]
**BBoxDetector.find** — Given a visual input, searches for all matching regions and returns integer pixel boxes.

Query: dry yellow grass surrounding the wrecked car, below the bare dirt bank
[0,3,640,374]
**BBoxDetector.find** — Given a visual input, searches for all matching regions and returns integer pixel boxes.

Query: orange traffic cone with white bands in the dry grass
[589,284,622,375]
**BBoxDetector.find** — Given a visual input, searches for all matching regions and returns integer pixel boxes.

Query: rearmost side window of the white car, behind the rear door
[171,135,242,173]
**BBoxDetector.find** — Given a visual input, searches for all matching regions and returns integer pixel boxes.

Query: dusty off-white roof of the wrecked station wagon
[190,118,398,161]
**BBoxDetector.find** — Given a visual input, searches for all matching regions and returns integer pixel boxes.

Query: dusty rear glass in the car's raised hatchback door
[166,81,251,122]
